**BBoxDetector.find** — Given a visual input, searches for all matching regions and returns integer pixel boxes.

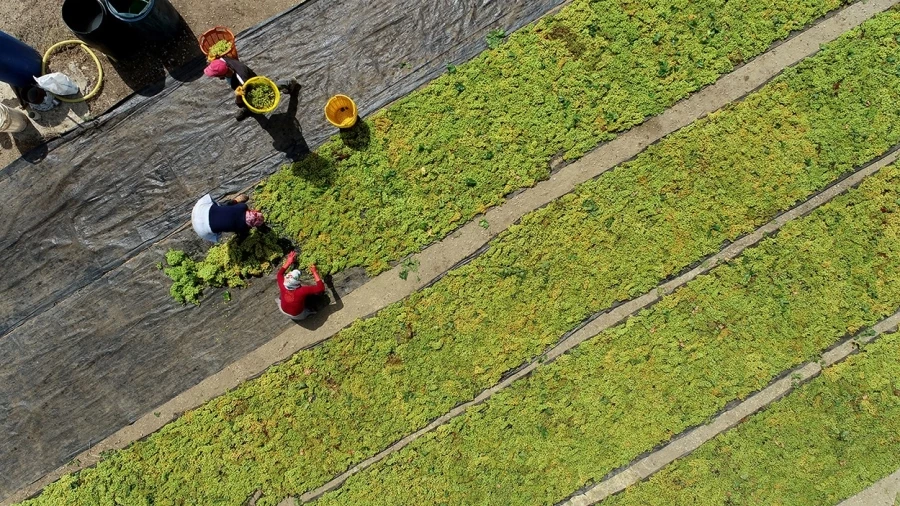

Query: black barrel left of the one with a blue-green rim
[62,0,136,58]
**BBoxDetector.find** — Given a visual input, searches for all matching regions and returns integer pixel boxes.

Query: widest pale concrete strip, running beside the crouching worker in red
[8,0,900,506]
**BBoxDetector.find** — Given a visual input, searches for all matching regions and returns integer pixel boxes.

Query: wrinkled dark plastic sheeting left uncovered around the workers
[0,0,561,499]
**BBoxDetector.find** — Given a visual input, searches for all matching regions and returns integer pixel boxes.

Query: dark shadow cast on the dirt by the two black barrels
[109,15,206,97]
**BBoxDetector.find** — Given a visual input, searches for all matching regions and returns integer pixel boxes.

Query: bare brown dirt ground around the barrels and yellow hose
[0,0,301,169]
